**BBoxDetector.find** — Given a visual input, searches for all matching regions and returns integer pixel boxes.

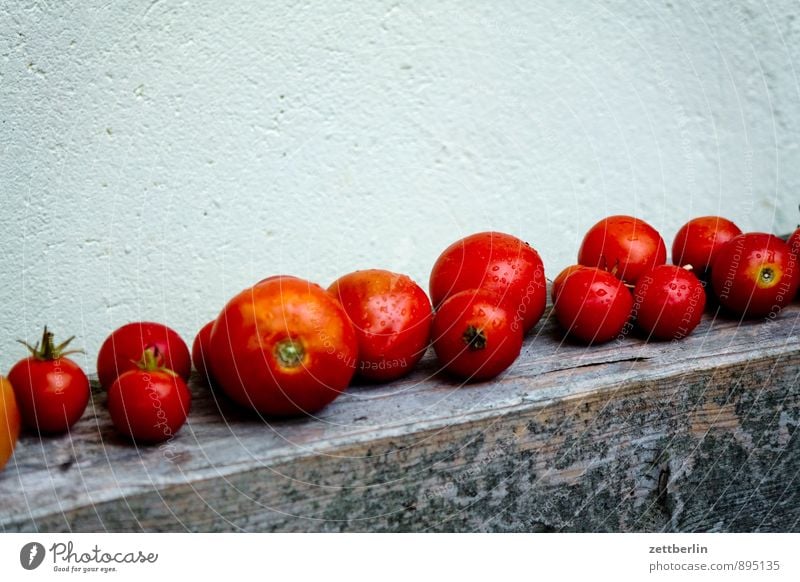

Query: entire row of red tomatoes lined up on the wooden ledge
[0,216,800,468]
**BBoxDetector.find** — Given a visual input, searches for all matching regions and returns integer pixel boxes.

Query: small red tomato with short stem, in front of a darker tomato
[108,347,192,443]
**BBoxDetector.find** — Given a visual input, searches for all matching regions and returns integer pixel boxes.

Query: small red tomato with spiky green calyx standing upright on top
[8,327,90,433]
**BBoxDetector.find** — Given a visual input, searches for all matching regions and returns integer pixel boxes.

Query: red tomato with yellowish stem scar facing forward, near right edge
[711,232,800,318]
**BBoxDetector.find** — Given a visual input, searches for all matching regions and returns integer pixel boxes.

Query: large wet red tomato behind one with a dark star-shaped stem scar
[430,232,547,331]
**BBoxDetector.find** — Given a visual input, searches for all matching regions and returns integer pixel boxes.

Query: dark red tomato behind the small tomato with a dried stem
[97,322,192,389]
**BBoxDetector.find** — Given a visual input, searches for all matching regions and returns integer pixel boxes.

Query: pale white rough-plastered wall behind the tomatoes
[0,0,800,371]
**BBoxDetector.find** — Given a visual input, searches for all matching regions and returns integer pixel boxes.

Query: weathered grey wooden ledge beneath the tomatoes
[0,306,800,531]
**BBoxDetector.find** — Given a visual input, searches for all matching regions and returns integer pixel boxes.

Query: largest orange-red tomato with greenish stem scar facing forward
[209,276,358,416]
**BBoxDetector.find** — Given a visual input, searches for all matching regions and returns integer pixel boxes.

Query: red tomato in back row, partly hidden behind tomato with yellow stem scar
[672,216,742,274]
